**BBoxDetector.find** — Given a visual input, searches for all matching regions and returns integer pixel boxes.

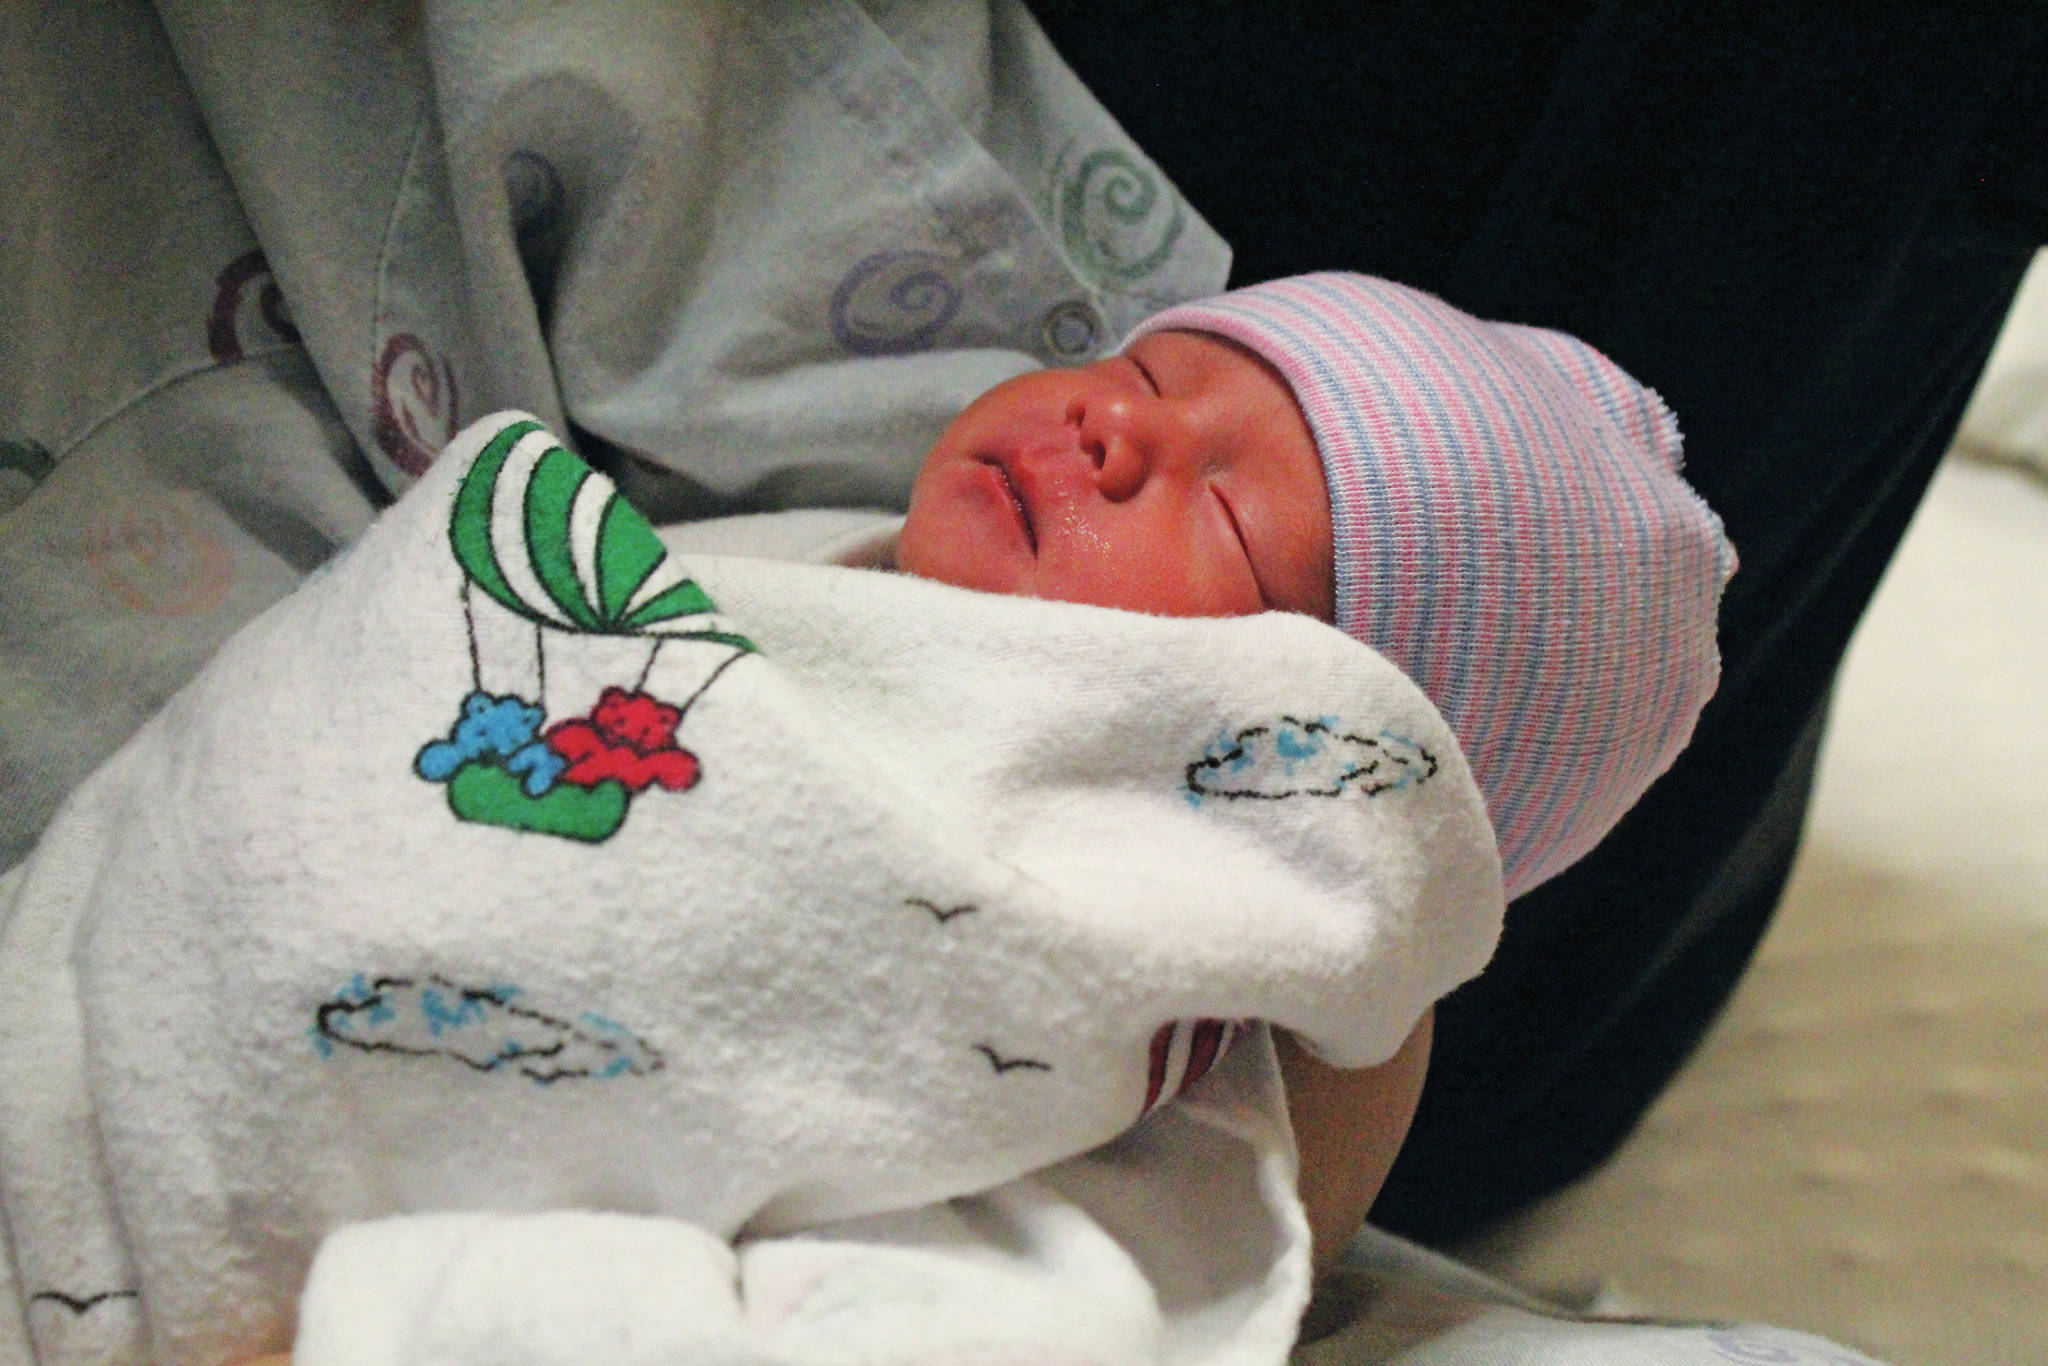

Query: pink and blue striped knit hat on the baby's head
[1133,274,1735,897]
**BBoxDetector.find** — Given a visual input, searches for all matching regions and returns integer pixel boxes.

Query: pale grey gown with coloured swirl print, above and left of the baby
[0,0,1229,866]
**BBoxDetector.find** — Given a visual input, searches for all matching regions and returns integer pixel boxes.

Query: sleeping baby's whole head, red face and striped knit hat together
[897,274,1735,895]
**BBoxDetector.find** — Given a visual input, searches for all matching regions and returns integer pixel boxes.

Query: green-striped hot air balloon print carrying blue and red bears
[414,420,754,842]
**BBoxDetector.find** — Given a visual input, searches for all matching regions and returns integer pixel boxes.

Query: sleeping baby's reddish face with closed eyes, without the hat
[897,332,1335,621]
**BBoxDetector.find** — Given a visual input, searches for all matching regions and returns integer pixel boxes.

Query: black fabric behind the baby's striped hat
[1032,0,2048,1243]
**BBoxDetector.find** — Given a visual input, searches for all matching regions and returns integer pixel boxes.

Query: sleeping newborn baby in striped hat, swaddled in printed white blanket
[0,276,1733,1366]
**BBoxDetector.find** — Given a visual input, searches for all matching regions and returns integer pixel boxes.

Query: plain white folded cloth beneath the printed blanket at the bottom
[293,1036,1309,1366]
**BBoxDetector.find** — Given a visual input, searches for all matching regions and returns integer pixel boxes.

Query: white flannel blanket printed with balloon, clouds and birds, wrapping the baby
[0,414,1501,1366]
